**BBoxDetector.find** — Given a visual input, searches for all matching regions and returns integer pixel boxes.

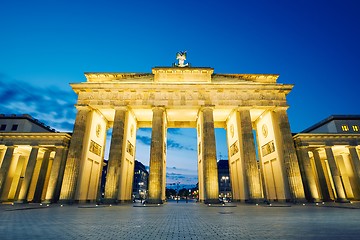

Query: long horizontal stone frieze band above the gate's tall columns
[78,89,286,106]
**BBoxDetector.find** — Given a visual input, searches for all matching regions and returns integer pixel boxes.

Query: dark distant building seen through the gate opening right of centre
[217,160,232,198]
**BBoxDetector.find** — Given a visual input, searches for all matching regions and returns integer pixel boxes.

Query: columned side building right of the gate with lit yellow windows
[294,115,360,202]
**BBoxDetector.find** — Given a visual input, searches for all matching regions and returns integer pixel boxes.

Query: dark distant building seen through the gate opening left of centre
[133,160,149,199]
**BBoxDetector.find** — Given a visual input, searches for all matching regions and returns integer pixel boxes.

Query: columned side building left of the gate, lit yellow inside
[0,114,71,202]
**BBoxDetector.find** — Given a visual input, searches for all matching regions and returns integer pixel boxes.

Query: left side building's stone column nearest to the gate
[45,146,65,203]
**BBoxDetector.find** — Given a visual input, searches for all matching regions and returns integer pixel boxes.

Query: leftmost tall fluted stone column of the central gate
[60,106,91,203]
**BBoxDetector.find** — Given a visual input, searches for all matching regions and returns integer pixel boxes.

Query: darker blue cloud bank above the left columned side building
[0,74,76,132]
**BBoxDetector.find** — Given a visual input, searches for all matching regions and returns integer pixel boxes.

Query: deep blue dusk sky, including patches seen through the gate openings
[0,0,360,188]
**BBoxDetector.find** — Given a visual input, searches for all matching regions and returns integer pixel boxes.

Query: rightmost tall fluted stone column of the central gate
[275,108,305,201]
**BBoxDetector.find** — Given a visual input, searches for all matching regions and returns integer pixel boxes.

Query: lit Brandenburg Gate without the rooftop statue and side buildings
[60,62,305,203]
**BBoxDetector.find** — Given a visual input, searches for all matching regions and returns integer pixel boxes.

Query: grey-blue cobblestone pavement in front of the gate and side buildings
[0,202,360,240]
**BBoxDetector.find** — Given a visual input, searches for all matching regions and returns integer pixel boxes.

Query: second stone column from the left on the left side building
[18,146,39,202]
